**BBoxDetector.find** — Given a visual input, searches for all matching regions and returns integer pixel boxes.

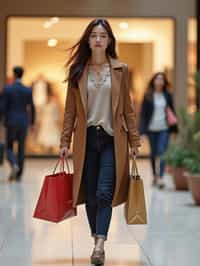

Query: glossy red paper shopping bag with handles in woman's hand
[33,159,77,223]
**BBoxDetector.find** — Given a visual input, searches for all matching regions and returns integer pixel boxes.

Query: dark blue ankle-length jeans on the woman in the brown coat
[83,126,115,240]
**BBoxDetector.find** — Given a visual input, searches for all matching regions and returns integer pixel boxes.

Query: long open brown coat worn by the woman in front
[60,58,140,206]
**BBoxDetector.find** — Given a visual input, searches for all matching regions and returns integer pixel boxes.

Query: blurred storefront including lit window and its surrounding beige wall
[0,0,196,155]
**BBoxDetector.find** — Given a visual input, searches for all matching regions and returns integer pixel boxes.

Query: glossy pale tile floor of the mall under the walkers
[0,160,200,266]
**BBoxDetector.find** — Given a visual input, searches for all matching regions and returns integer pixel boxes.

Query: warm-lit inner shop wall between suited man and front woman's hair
[23,41,71,105]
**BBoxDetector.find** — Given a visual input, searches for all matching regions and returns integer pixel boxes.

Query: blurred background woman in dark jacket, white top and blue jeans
[140,72,178,189]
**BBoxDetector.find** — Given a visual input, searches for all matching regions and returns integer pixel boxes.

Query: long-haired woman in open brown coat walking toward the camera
[60,19,140,264]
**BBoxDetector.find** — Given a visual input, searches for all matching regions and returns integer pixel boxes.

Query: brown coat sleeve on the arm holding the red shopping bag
[60,86,76,149]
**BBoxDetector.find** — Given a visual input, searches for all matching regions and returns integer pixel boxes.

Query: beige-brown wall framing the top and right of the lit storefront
[0,0,195,106]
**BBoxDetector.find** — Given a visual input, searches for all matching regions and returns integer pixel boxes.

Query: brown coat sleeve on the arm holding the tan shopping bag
[124,65,141,147]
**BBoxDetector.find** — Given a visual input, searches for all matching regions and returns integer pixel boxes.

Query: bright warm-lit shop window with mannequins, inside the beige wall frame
[6,17,174,154]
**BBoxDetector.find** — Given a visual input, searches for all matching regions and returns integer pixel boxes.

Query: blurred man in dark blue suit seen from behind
[3,66,35,181]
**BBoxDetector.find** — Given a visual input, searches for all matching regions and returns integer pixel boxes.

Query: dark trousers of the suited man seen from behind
[6,126,27,180]
